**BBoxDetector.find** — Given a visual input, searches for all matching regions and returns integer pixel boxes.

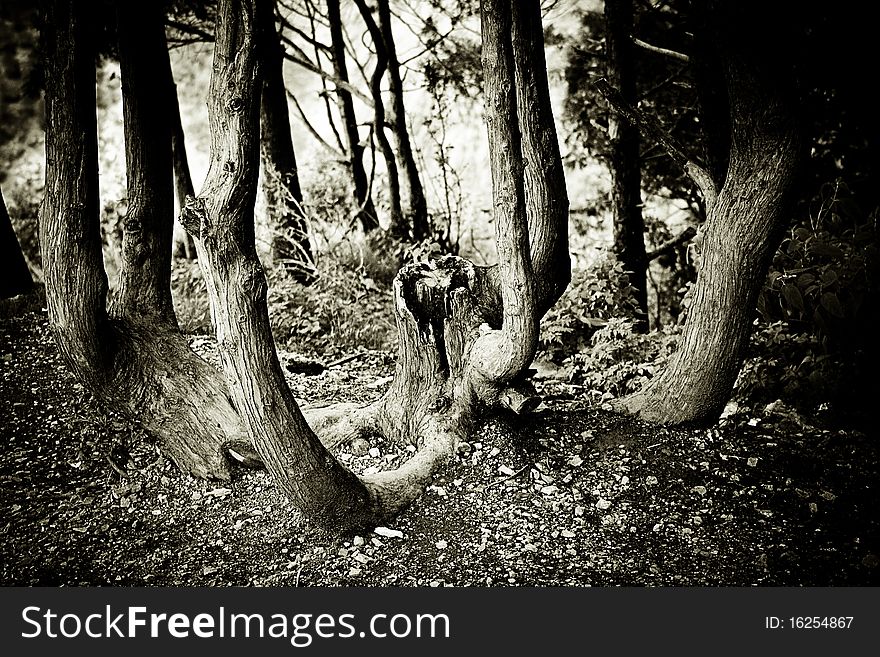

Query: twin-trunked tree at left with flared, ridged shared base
[40,0,253,479]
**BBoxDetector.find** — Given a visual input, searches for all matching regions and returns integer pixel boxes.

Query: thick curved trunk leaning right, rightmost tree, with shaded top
[622,2,801,424]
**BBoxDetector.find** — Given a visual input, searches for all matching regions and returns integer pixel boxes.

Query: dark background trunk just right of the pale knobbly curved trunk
[260,3,315,285]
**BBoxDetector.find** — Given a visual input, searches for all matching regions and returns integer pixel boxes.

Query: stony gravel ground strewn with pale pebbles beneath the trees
[0,308,880,587]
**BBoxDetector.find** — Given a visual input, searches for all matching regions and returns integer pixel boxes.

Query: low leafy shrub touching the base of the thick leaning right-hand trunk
[571,317,674,399]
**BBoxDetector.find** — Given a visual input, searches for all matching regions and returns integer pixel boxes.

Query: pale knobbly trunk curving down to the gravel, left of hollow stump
[184,0,378,531]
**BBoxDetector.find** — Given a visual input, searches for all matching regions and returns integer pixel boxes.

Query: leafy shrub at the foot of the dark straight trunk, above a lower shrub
[538,257,638,362]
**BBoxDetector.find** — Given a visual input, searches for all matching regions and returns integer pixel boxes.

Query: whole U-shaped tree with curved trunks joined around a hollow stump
[183,0,568,530]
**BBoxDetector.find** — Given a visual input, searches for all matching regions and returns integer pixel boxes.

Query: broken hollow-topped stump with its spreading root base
[303,256,540,518]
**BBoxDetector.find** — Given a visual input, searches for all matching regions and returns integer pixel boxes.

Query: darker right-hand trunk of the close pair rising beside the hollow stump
[511,2,571,316]
